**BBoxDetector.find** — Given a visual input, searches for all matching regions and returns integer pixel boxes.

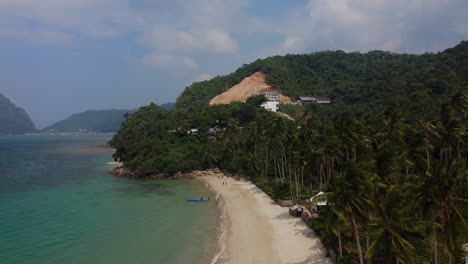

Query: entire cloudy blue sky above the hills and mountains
[0,0,468,128]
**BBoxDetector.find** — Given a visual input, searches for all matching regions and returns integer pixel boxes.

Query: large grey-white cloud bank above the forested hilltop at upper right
[276,0,468,53]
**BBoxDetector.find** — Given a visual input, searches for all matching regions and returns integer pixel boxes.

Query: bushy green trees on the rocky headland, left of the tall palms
[110,103,264,175]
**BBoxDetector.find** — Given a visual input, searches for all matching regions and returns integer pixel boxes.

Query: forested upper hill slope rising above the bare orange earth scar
[176,41,468,118]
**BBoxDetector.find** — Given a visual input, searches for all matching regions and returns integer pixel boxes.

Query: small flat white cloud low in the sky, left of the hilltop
[143,53,198,69]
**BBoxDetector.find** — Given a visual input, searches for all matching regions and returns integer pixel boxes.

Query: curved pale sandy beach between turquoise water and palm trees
[199,176,332,264]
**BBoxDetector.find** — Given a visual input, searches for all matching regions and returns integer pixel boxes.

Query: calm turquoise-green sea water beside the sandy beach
[0,135,216,264]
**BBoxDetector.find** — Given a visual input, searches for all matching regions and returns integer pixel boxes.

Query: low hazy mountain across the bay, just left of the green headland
[41,109,132,132]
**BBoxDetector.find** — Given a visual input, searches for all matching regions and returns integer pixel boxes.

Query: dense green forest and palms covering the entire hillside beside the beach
[110,42,468,264]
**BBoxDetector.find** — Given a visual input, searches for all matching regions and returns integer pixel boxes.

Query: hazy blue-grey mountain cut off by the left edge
[0,93,36,135]
